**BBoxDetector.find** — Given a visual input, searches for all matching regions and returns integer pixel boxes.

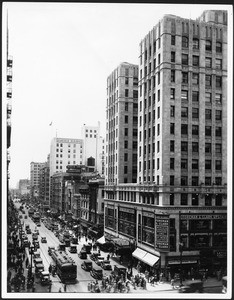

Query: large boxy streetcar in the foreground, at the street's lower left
[51,250,77,282]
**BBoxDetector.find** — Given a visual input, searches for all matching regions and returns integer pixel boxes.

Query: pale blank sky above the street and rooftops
[2,2,230,188]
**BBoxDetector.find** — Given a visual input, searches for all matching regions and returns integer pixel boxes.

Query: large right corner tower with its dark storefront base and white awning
[105,11,227,276]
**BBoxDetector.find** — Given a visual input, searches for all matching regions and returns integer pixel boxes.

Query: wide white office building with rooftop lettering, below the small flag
[50,137,83,176]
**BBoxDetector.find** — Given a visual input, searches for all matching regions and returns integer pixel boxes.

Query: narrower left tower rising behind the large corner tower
[105,62,138,185]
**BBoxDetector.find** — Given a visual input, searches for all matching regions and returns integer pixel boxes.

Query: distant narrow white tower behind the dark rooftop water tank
[81,123,105,175]
